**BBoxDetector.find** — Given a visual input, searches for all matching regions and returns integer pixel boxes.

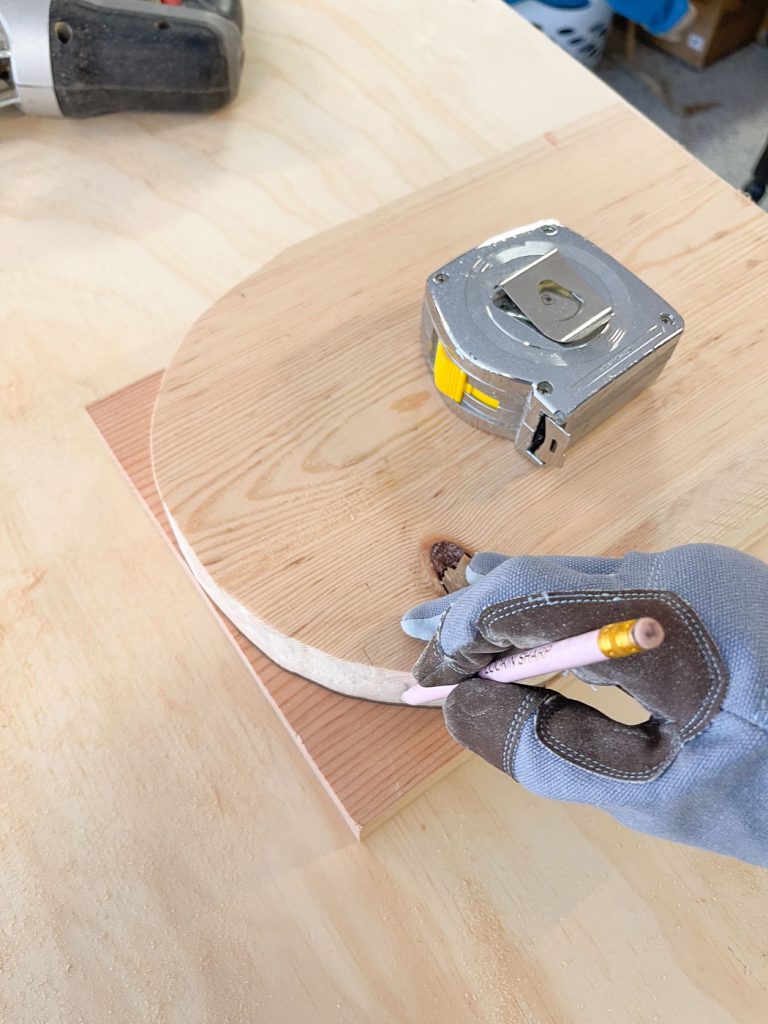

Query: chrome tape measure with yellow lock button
[422,220,683,466]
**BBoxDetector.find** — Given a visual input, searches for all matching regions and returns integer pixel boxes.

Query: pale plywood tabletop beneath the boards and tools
[0,0,768,1024]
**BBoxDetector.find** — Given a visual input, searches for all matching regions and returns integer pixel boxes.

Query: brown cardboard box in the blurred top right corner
[649,0,768,68]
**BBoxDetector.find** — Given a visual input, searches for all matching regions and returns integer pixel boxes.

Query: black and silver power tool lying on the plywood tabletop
[0,0,243,118]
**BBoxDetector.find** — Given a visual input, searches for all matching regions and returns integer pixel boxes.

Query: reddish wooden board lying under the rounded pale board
[88,373,466,838]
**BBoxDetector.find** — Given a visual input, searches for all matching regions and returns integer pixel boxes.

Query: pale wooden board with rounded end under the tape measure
[153,106,768,701]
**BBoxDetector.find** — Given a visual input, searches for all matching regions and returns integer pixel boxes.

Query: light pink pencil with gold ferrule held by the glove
[400,617,664,706]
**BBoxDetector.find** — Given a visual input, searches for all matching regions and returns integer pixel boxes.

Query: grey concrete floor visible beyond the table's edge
[597,30,768,202]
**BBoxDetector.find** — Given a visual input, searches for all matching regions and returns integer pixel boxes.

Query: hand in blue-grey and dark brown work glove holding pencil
[402,545,768,866]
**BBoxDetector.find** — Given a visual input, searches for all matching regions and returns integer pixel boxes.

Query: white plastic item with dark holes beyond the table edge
[507,0,613,68]
